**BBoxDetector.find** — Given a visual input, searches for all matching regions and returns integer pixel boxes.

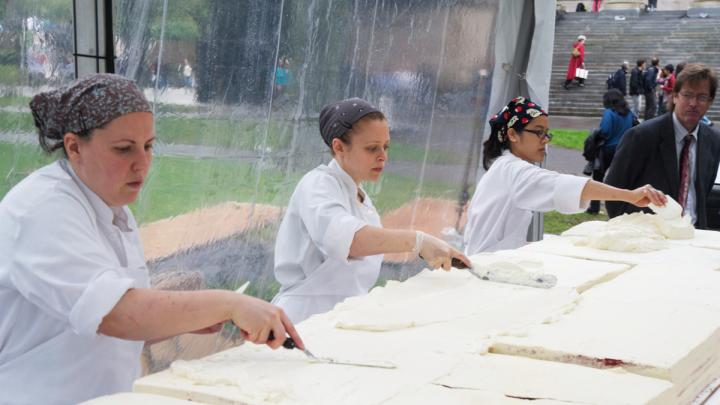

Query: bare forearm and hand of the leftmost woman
[98,288,304,349]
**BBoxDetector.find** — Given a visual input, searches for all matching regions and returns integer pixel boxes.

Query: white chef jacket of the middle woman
[273,160,383,323]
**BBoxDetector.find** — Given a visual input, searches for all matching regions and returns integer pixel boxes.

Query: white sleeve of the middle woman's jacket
[298,176,368,262]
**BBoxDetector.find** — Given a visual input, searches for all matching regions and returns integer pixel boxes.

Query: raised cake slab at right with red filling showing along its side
[490,264,720,403]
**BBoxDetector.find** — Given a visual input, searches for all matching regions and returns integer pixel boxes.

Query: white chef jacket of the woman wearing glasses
[463,150,590,255]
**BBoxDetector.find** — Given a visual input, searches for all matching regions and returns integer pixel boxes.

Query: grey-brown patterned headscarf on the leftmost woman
[30,74,152,153]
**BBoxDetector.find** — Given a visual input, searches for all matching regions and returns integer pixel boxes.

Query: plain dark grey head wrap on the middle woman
[320,98,380,146]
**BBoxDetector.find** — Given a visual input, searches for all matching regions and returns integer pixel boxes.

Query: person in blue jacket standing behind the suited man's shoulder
[586,89,636,215]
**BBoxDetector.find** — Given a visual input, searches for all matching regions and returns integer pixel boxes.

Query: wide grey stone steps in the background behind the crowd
[549,11,720,122]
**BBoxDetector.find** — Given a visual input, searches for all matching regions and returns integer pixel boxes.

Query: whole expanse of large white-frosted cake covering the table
[135,245,720,405]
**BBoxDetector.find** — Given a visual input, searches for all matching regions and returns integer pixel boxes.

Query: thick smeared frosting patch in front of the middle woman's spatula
[332,266,576,332]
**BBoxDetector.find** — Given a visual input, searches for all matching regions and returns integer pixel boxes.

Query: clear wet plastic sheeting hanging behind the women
[0,0,499,371]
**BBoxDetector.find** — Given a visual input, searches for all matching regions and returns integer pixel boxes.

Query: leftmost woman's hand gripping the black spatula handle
[229,294,305,349]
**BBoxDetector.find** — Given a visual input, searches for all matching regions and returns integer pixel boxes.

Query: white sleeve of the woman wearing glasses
[509,162,590,214]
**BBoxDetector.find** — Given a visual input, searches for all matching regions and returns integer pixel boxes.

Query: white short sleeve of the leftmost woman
[9,193,135,336]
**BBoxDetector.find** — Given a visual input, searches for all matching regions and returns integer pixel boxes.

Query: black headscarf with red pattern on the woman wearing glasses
[483,97,548,170]
